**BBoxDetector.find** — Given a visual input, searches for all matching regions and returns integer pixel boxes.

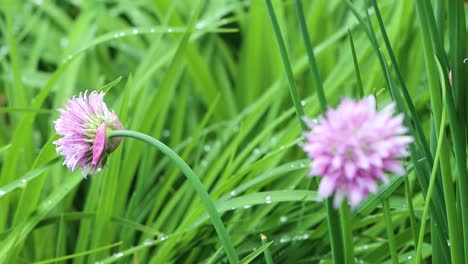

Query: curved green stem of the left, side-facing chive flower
[107,130,239,263]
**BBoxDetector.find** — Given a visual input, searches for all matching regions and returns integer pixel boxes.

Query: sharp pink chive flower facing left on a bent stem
[54,91,124,178]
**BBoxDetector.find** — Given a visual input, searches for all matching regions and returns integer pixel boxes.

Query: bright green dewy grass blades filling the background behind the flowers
[0,0,468,263]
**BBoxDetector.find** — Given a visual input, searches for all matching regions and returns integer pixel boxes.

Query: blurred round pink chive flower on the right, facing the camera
[303,96,413,209]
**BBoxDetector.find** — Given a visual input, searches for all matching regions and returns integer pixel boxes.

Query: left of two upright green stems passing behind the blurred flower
[265,0,344,263]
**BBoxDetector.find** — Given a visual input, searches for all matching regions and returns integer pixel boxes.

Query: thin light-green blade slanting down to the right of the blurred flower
[416,98,445,264]
